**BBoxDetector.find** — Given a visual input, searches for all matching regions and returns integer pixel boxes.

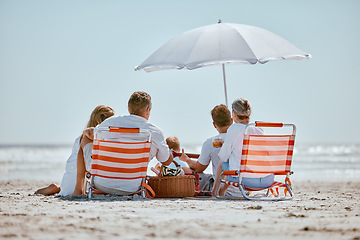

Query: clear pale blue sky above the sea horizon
[0,0,360,144]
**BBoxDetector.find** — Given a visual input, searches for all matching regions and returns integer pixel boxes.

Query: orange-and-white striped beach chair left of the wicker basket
[85,127,155,199]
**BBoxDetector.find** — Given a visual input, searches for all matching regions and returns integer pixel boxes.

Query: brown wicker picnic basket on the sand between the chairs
[148,166,195,198]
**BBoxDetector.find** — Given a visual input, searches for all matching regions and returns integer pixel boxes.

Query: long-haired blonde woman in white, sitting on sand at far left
[35,105,114,196]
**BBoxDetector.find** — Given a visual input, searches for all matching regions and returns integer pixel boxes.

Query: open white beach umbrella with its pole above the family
[135,20,311,105]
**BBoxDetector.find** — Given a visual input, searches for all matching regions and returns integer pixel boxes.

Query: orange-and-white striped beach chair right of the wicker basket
[215,122,296,200]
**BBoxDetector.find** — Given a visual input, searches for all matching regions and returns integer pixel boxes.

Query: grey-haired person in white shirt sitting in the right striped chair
[213,98,274,195]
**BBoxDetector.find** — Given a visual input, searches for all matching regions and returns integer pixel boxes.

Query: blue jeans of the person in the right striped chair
[222,162,274,188]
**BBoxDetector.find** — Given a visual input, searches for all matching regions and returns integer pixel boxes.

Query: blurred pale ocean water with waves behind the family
[0,144,360,183]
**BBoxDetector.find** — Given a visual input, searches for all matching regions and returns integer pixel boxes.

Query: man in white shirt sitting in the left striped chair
[73,92,173,195]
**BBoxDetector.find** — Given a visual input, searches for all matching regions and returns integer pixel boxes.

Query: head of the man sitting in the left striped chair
[128,92,152,119]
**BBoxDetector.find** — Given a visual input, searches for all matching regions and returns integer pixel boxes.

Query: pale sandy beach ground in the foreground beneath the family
[0,180,360,240]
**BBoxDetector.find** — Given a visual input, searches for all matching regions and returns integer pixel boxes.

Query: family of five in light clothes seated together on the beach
[35,92,274,196]
